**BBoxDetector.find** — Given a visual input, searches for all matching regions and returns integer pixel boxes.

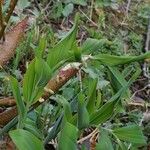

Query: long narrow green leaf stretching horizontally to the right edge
[93,52,150,66]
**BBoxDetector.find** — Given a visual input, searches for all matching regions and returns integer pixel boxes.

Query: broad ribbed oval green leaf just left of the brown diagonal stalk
[23,58,51,105]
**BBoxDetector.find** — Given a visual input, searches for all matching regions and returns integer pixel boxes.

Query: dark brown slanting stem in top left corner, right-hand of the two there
[0,0,18,39]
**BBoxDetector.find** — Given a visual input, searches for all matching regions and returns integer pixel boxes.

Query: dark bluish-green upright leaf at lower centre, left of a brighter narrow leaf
[78,93,89,129]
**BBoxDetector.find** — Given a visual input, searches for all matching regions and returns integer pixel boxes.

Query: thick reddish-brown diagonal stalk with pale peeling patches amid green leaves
[0,63,82,126]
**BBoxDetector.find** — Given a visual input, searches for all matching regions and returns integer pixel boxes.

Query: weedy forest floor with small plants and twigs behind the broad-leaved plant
[0,0,150,150]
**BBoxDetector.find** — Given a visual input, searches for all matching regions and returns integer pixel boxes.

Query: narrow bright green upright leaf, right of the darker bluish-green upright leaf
[87,79,98,114]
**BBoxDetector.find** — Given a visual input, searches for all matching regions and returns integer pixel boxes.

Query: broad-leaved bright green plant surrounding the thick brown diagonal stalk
[0,13,150,150]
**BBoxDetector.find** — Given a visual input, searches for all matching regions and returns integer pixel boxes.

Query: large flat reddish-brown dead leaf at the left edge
[0,18,28,66]
